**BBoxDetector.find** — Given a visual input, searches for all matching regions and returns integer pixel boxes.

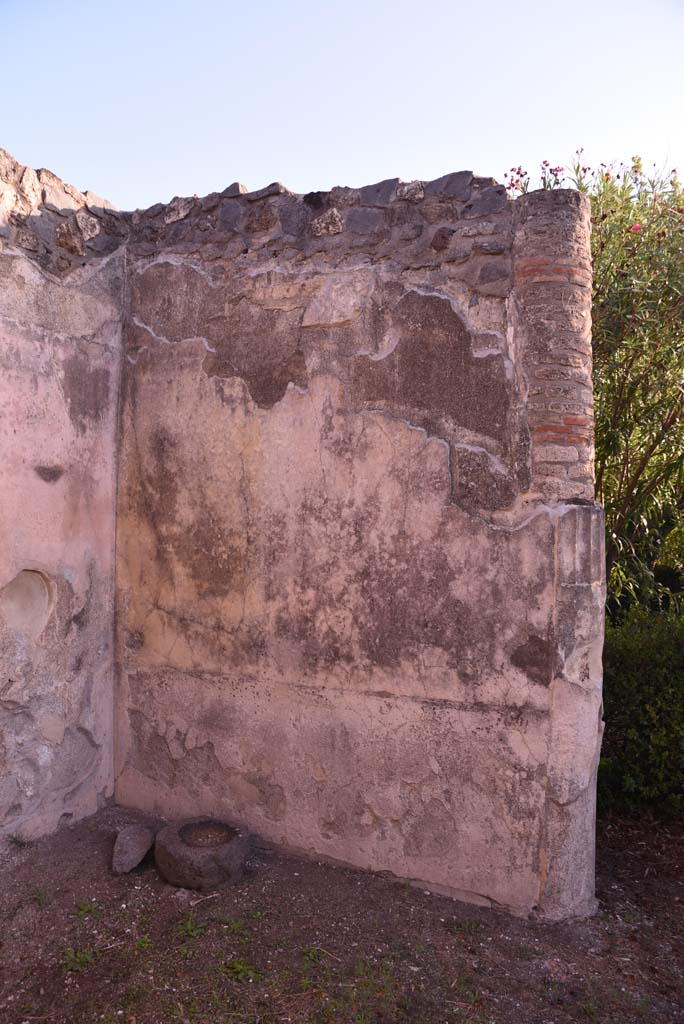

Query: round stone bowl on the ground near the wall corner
[155,818,252,889]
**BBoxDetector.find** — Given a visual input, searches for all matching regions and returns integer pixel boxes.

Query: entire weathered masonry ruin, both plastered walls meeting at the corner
[0,151,604,919]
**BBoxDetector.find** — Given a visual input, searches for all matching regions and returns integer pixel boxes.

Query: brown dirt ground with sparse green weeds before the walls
[0,807,684,1024]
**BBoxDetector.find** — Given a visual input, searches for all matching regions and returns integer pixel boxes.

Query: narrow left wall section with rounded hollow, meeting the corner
[0,151,123,837]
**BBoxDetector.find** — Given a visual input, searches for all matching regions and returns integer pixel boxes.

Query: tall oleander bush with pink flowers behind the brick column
[506,151,684,614]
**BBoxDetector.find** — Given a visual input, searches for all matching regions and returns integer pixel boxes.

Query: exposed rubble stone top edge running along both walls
[0,150,587,278]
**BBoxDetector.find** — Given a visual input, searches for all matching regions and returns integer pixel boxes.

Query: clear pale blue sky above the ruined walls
[0,0,684,209]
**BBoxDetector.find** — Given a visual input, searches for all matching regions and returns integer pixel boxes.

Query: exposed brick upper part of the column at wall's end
[511,188,594,501]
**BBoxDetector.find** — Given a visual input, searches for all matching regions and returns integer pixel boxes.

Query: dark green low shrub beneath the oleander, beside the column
[599,608,684,816]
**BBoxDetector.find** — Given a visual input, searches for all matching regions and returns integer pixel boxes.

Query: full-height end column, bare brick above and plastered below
[510,189,605,920]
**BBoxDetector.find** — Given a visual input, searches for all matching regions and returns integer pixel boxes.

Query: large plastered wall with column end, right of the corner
[117,173,603,916]
